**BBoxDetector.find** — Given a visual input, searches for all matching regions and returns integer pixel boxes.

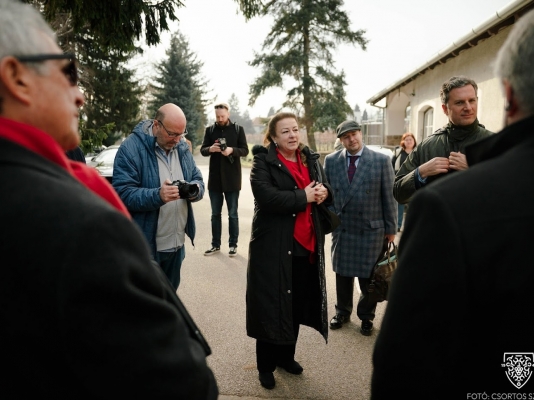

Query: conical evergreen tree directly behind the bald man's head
[149,32,209,146]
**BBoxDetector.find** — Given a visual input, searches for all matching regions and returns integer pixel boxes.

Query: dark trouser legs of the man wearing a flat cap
[336,274,377,321]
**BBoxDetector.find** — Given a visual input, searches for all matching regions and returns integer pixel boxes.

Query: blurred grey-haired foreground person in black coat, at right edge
[372,11,534,399]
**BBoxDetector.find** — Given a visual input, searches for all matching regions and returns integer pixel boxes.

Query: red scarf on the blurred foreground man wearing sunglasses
[0,117,130,218]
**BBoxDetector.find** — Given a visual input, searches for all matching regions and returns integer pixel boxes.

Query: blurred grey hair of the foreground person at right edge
[495,10,534,114]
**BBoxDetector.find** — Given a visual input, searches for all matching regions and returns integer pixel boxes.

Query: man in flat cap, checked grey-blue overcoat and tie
[324,121,397,336]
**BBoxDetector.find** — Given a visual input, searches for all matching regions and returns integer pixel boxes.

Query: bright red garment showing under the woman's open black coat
[276,149,316,254]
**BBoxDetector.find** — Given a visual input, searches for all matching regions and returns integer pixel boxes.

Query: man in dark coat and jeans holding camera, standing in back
[200,103,248,257]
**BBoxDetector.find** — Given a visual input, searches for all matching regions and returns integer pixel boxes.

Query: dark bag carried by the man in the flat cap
[367,239,398,302]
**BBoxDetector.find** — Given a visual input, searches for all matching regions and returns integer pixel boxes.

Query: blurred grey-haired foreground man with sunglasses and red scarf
[0,0,217,399]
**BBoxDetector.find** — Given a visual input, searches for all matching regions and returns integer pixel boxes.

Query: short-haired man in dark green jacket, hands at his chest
[393,76,493,204]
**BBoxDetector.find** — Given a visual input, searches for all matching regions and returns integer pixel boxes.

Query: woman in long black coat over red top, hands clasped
[246,112,332,389]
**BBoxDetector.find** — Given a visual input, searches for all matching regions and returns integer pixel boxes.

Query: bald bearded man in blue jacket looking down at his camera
[113,103,204,289]
